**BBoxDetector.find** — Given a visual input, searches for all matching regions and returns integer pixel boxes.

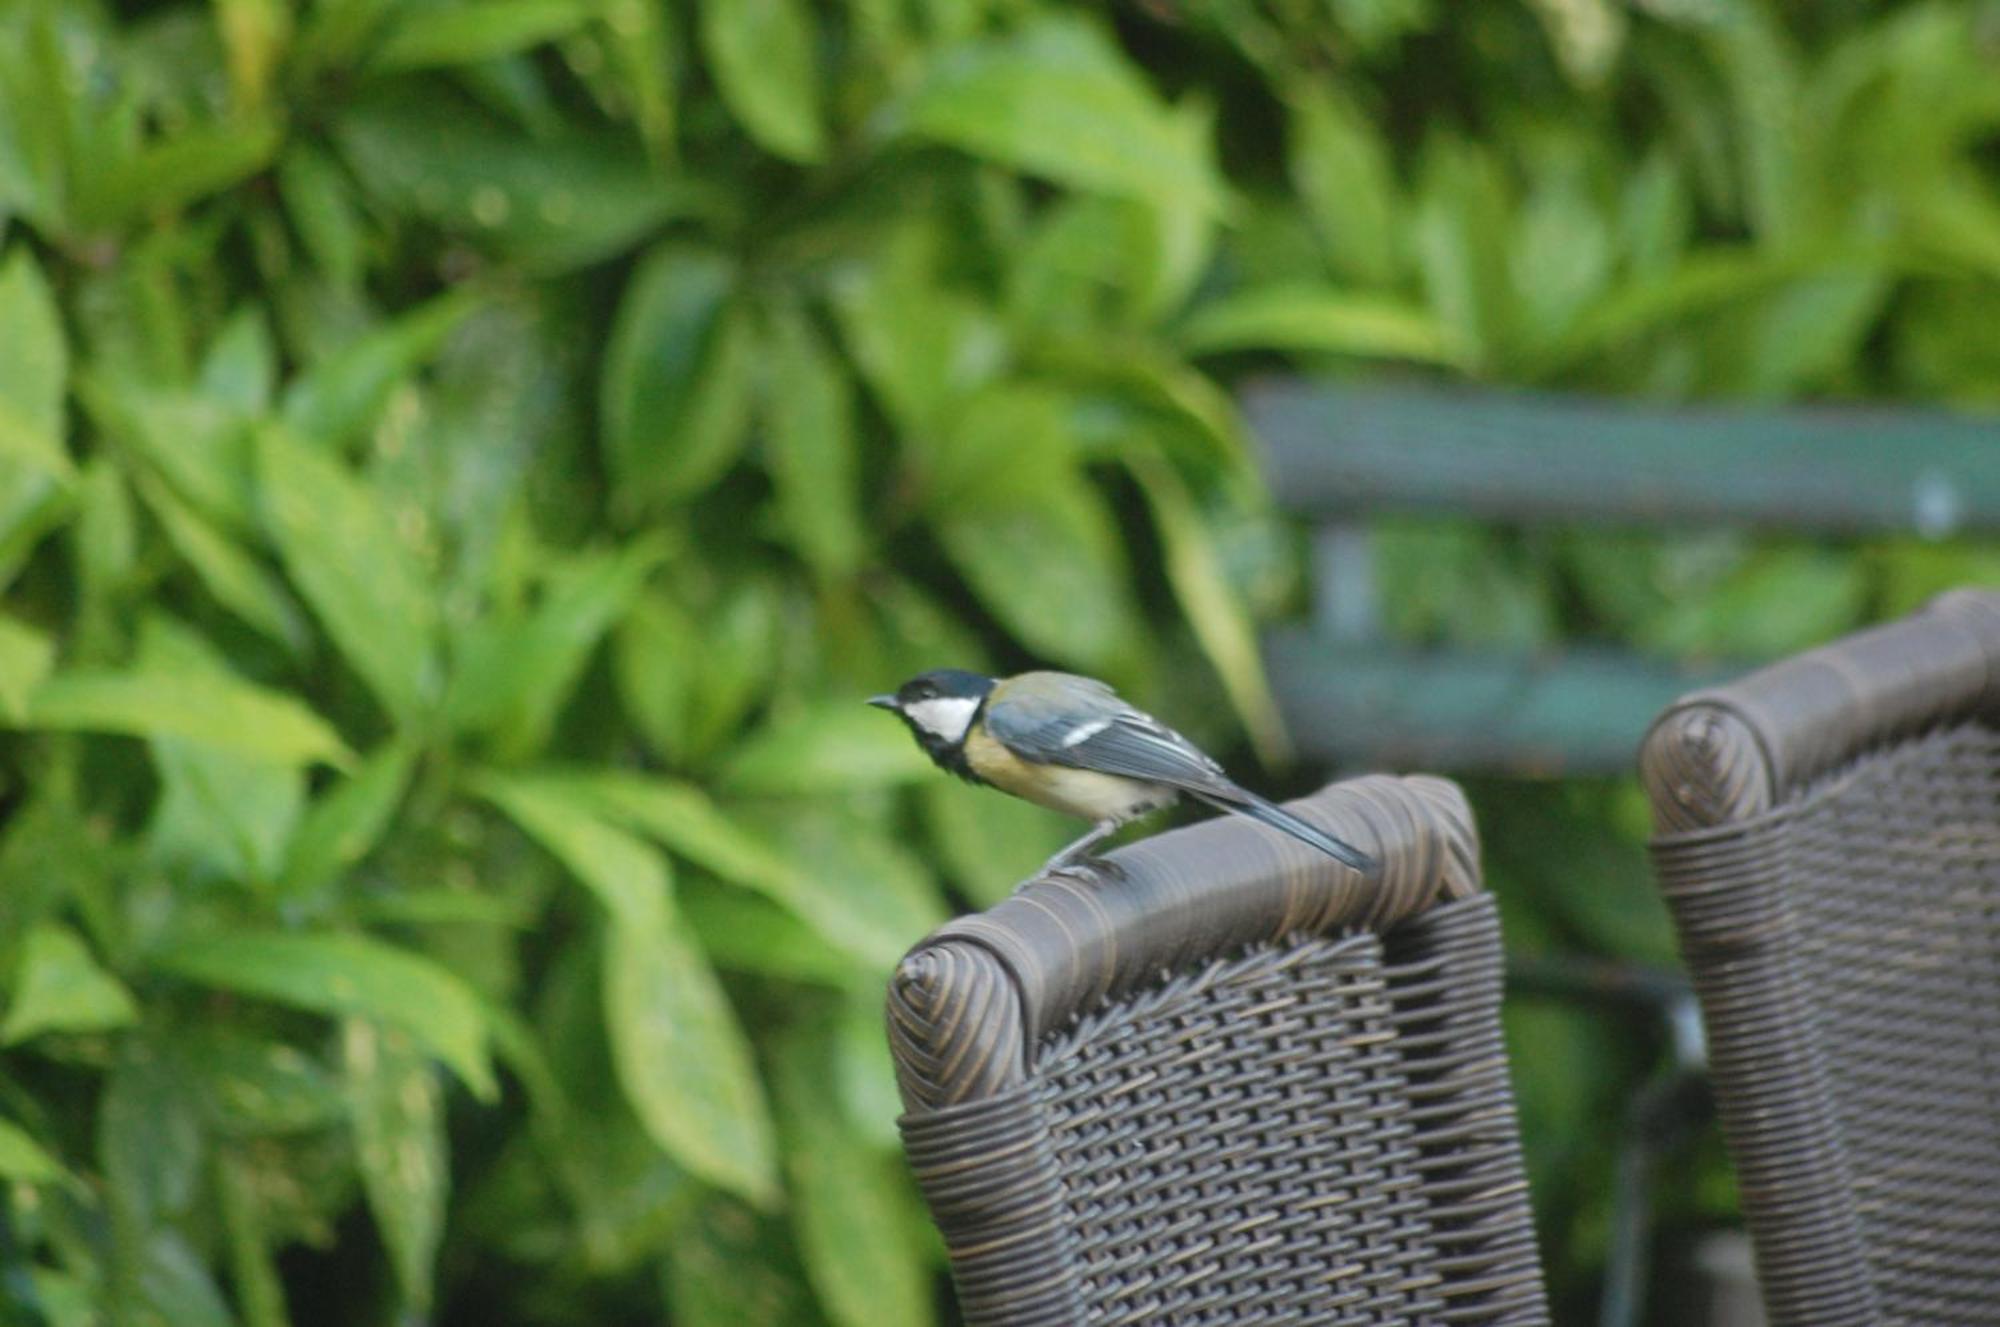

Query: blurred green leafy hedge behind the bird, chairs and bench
[0,0,2000,1327]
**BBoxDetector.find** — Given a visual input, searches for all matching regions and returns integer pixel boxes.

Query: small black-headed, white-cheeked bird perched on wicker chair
[868,667,1376,875]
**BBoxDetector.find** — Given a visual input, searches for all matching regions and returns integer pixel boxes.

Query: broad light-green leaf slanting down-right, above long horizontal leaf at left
[258,428,438,725]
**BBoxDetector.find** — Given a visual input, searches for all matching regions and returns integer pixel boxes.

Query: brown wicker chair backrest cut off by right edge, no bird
[1642,592,2000,1327]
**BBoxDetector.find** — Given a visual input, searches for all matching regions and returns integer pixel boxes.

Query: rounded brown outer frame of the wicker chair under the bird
[888,775,1548,1327]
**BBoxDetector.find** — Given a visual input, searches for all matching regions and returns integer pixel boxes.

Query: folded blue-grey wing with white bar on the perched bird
[986,677,1236,793]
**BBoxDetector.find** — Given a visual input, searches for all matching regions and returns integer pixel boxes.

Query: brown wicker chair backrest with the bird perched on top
[888,777,1548,1327]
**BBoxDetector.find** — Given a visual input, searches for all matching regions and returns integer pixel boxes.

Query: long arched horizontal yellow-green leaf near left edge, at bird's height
[20,669,352,765]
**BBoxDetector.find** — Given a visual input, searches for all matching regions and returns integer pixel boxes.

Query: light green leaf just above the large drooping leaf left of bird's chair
[472,773,672,935]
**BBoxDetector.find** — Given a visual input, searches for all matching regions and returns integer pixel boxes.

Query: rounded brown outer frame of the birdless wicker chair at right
[1640,592,2000,1327]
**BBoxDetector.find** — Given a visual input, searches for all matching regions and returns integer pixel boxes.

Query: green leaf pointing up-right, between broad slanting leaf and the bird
[446,538,666,757]
